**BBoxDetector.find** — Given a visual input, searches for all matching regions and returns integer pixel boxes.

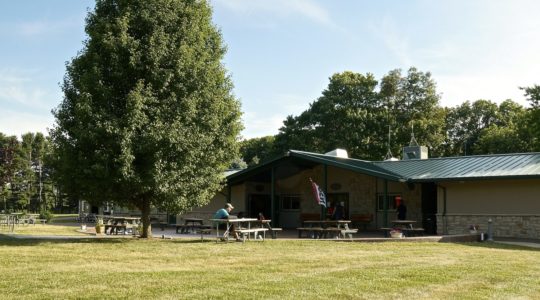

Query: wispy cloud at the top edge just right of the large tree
[212,0,334,26]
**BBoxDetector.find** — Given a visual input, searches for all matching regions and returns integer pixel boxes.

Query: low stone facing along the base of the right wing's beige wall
[437,214,540,239]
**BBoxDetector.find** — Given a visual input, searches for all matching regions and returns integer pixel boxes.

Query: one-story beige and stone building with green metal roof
[177,146,540,239]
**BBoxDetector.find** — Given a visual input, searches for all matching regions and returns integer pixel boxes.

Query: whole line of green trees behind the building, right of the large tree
[240,68,540,165]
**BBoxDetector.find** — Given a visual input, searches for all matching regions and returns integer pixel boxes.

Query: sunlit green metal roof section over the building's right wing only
[373,153,540,182]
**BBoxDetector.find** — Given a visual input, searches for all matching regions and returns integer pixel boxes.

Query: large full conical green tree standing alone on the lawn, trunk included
[51,0,241,237]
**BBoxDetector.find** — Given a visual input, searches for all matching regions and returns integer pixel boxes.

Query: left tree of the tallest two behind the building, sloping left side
[276,71,380,157]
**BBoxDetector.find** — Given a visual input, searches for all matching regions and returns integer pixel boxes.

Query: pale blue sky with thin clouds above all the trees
[0,0,540,138]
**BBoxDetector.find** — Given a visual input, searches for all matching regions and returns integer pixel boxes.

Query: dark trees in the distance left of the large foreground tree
[0,133,77,213]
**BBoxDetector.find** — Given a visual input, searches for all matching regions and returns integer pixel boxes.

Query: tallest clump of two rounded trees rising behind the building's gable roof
[275,68,445,160]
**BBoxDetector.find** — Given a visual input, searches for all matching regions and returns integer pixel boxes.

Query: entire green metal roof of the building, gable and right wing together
[227,150,540,183]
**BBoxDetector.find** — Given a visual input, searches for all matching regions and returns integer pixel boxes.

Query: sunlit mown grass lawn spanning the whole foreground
[0,237,540,299]
